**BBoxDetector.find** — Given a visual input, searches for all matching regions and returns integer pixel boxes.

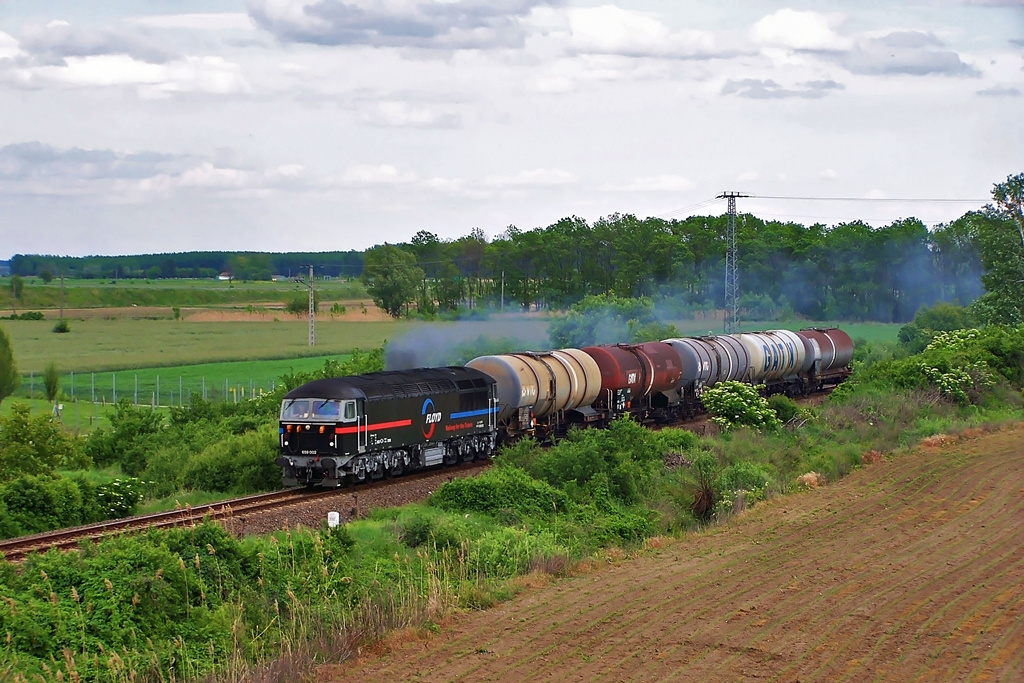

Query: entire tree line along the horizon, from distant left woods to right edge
[11,174,1024,323]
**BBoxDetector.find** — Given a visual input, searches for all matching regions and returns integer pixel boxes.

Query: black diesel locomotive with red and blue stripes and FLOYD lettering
[275,367,498,486]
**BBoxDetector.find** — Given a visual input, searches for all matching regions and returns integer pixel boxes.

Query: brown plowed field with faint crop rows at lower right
[321,427,1024,683]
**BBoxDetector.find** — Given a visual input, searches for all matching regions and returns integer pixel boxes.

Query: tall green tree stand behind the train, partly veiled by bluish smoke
[362,213,991,323]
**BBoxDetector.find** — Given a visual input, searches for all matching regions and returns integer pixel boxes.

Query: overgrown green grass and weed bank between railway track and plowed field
[0,388,1020,681]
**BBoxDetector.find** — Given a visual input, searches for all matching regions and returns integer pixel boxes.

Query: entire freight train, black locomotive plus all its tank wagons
[275,328,853,486]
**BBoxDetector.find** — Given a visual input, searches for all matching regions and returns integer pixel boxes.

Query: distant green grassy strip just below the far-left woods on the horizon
[0,278,367,311]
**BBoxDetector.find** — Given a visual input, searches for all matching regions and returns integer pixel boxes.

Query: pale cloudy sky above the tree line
[0,0,1024,259]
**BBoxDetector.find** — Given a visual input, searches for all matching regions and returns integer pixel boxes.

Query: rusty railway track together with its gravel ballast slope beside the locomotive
[0,461,490,561]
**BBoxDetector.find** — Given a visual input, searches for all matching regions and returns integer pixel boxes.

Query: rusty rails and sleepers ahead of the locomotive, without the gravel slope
[0,460,490,562]
